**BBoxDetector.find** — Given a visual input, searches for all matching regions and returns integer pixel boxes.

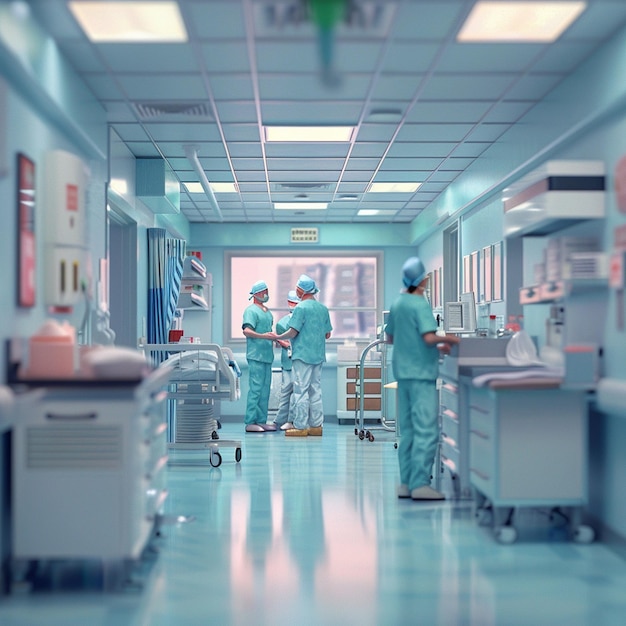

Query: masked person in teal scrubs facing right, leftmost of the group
[242,280,276,433]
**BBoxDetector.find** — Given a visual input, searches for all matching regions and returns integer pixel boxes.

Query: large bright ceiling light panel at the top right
[457,1,587,42]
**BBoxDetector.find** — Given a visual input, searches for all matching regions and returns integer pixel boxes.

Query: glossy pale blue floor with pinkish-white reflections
[0,424,626,626]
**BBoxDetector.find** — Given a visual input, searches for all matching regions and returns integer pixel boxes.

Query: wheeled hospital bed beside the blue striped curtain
[140,343,241,467]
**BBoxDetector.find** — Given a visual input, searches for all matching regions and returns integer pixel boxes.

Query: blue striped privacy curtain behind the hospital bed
[147,228,186,365]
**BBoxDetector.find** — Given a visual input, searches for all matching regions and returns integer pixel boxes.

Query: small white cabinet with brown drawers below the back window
[337,363,383,424]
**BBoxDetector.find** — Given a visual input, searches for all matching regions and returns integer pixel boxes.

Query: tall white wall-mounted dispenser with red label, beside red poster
[43,150,89,310]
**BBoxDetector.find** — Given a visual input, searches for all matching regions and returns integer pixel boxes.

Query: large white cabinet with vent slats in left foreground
[12,370,169,583]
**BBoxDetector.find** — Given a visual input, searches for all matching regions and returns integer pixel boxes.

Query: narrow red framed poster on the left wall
[17,154,36,307]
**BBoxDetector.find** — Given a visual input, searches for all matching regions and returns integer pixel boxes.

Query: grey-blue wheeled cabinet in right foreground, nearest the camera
[469,380,594,543]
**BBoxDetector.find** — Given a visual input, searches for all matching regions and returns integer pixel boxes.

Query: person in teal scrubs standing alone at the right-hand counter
[385,257,460,500]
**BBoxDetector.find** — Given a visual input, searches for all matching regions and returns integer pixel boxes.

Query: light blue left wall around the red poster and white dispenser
[0,5,107,380]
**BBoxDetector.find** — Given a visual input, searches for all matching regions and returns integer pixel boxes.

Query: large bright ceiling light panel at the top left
[68,0,187,43]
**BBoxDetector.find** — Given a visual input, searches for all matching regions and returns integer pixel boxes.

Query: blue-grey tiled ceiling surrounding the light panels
[29,0,626,223]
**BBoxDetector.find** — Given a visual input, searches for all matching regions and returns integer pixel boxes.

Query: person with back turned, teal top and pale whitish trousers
[277,274,333,437]
